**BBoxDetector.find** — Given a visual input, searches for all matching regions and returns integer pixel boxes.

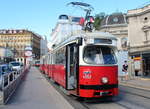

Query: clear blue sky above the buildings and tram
[0,0,150,40]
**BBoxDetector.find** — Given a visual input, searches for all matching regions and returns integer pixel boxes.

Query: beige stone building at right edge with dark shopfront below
[127,5,150,75]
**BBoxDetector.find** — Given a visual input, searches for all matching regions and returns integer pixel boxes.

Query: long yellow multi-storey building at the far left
[0,30,41,61]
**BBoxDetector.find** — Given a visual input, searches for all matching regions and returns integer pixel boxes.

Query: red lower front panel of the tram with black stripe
[79,66,118,97]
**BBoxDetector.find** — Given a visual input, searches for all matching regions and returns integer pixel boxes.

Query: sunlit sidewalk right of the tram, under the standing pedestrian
[119,76,150,91]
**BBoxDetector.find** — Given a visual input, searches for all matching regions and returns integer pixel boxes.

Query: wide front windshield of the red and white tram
[83,46,117,64]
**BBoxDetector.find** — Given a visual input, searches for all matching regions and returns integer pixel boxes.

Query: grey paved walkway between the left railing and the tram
[0,67,73,109]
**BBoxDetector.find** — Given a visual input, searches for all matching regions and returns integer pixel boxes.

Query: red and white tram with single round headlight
[40,32,118,98]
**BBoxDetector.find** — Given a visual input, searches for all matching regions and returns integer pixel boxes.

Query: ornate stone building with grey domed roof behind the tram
[100,13,128,50]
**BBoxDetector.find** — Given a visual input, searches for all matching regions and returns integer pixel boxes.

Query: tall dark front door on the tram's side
[67,44,78,90]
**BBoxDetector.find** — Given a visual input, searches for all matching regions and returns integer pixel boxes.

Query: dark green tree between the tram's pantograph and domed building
[94,12,106,30]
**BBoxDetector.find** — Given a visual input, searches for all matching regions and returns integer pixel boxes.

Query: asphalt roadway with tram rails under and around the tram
[47,73,150,109]
